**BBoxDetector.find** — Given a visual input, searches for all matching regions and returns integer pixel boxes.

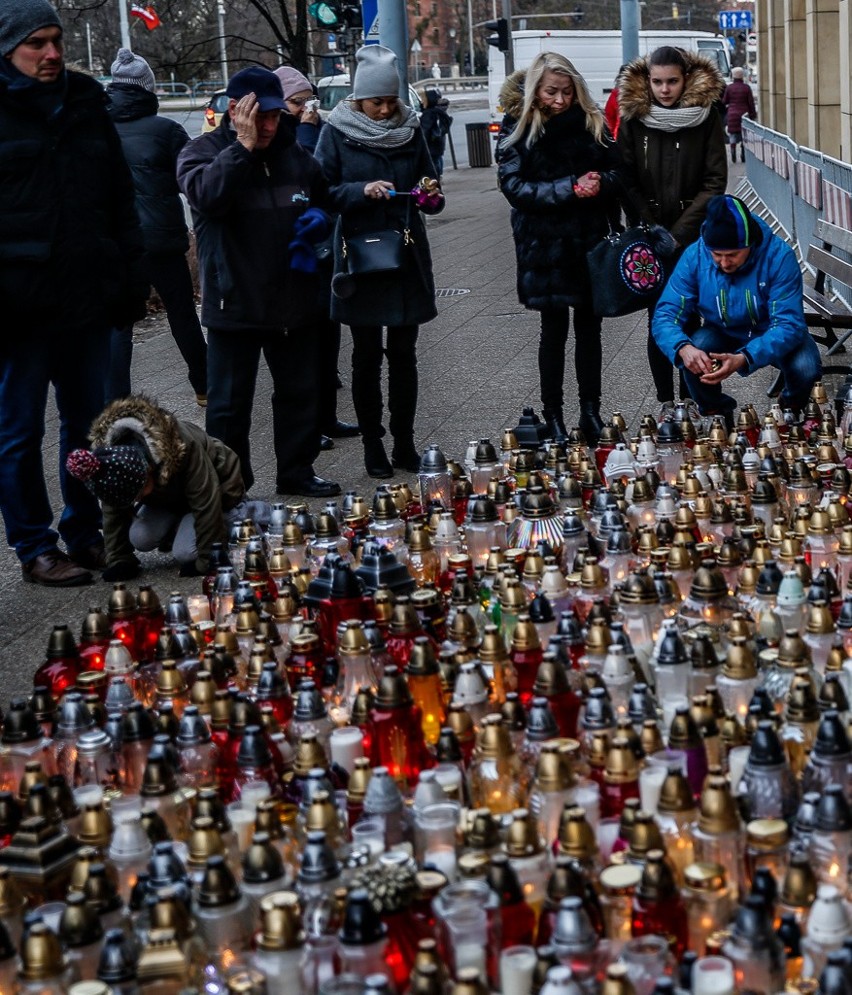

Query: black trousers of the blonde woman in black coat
[538,304,602,411]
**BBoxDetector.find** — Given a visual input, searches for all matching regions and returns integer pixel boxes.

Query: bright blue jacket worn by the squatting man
[651,219,808,375]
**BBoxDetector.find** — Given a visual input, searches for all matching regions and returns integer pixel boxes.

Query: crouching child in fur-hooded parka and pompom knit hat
[67,396,245,580]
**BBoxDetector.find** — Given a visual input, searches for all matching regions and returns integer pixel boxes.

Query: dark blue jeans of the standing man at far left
[0,328,109,563]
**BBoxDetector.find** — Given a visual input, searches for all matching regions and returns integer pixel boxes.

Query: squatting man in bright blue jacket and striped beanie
[652,194,822,421]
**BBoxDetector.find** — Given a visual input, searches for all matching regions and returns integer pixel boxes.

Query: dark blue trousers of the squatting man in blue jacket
[683,328,822,414]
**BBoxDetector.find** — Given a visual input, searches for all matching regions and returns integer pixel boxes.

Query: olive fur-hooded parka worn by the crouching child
[89,396,245,572]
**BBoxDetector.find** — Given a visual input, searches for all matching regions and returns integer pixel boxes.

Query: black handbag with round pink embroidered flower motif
[586,224,670,318]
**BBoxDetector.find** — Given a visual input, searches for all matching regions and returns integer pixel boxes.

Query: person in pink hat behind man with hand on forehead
[275,66,360,450]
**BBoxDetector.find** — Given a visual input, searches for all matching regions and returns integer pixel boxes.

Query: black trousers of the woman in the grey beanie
[352,325,418,444]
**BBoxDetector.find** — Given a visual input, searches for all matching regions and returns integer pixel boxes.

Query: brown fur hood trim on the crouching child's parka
[89,394,186,487]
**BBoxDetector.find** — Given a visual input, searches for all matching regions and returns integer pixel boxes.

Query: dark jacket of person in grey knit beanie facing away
[107,83,189,252]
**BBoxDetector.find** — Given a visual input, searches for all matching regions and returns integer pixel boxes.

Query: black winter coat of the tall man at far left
[0,69,148,334]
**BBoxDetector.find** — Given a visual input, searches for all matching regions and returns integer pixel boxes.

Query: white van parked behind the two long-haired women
[488,30,731,131]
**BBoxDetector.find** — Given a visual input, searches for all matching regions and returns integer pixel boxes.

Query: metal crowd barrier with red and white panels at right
[743,118,852,309]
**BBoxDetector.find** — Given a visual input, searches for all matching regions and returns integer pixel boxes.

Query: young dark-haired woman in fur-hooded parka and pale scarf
[618,46,728,411]
